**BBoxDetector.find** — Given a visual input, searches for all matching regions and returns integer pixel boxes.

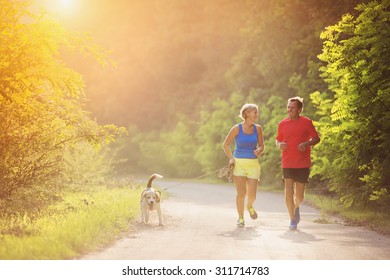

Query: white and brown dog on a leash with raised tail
[141,174,163,226]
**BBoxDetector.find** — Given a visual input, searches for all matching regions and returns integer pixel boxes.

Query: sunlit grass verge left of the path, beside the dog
[0,188,140,260]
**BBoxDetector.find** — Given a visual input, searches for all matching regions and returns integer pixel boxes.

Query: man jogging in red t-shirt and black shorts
[275,97,320,229]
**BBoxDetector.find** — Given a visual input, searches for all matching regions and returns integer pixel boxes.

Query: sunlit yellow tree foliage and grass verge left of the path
[0,0,129,259]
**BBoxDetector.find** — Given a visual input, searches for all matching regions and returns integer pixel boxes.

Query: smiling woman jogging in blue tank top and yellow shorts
[223,104,264,227]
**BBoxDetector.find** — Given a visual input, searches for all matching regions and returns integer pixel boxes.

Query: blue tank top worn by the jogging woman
[233,124,258,158]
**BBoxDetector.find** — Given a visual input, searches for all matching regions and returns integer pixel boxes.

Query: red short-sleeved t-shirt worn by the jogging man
[276,116,318,168]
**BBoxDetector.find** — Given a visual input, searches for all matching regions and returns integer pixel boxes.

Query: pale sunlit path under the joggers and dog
[83,180,390,260]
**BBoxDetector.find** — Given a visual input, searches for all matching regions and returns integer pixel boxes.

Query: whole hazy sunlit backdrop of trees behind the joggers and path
[0,0,390,218]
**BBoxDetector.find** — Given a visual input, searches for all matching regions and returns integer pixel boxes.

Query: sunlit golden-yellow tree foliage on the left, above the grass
[0,1,124,205]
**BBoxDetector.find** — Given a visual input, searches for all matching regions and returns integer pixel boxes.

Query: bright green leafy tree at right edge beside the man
[312,1,390,207]
